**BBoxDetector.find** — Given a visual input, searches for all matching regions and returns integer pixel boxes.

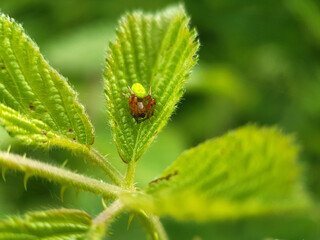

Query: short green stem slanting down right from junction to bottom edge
[137,210,169,240]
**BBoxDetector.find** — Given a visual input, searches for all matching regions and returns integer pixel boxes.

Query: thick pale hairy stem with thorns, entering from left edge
[0,152,124,198]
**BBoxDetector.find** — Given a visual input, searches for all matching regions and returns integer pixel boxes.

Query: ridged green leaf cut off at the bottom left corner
[0,209,92,240]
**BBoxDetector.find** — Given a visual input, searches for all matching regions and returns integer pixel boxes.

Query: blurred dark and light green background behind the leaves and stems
[0,0,320,240]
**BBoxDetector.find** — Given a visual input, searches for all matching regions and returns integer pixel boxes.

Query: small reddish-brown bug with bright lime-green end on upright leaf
[122,83,156,123]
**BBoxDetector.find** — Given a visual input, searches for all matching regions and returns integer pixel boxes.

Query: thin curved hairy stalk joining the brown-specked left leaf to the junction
[50,138,124,186]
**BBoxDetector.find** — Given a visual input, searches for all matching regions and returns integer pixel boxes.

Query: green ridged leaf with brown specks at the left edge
[0,14,94,146]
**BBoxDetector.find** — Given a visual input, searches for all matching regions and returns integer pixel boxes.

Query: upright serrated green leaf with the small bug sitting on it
[105,7,199,162]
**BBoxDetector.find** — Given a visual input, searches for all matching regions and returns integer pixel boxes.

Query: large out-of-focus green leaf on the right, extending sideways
[122,126,308,221]
